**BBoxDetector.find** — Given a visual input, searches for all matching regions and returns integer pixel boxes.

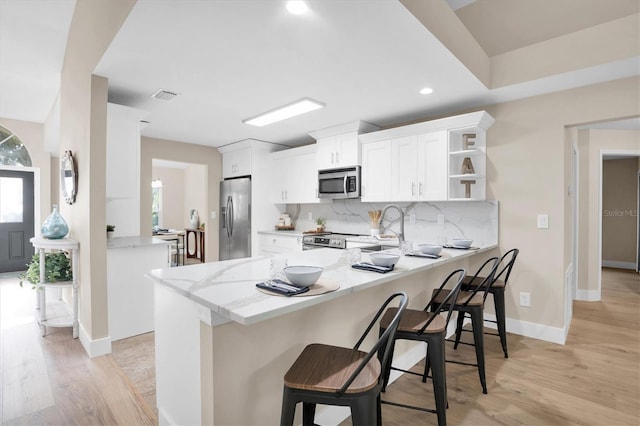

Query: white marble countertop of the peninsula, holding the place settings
[145,245,496,325]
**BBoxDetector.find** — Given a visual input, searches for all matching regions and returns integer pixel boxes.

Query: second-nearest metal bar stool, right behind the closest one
[380,269,466,426]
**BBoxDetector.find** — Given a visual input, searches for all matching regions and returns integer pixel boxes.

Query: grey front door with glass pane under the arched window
[0,170,34,272]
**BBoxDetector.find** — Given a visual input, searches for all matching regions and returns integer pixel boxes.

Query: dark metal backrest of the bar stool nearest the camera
[336,291,409,395]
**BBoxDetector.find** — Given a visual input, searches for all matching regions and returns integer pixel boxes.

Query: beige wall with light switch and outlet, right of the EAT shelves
[486,78,640,327]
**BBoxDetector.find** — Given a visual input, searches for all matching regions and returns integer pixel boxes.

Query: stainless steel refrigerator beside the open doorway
[219,177,251,260]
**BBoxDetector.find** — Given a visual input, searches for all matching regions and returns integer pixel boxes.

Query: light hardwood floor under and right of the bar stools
[350,269,640,426]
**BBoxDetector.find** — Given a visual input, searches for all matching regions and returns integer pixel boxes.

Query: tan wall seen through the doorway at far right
[602,157,640,265]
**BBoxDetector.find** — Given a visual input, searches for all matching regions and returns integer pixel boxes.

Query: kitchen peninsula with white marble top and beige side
[147,245,497,425]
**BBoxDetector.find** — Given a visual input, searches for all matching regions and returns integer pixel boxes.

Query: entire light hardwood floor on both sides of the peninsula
[0,269,640,426]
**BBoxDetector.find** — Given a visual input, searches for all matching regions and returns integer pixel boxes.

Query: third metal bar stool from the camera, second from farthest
[431,257,499,394]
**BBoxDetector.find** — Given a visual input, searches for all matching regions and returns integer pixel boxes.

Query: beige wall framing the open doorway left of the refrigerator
[140,136,222,261]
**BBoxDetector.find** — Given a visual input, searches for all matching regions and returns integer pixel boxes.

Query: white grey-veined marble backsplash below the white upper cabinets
[287,200,498,246]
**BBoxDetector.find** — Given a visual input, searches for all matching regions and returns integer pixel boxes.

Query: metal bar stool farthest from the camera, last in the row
[456,248,520,358]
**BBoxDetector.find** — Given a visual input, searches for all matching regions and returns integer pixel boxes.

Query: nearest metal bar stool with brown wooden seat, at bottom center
[280,292,409,426]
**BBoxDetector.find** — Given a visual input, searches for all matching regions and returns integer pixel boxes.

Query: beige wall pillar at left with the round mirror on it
[59,0,135,346]
